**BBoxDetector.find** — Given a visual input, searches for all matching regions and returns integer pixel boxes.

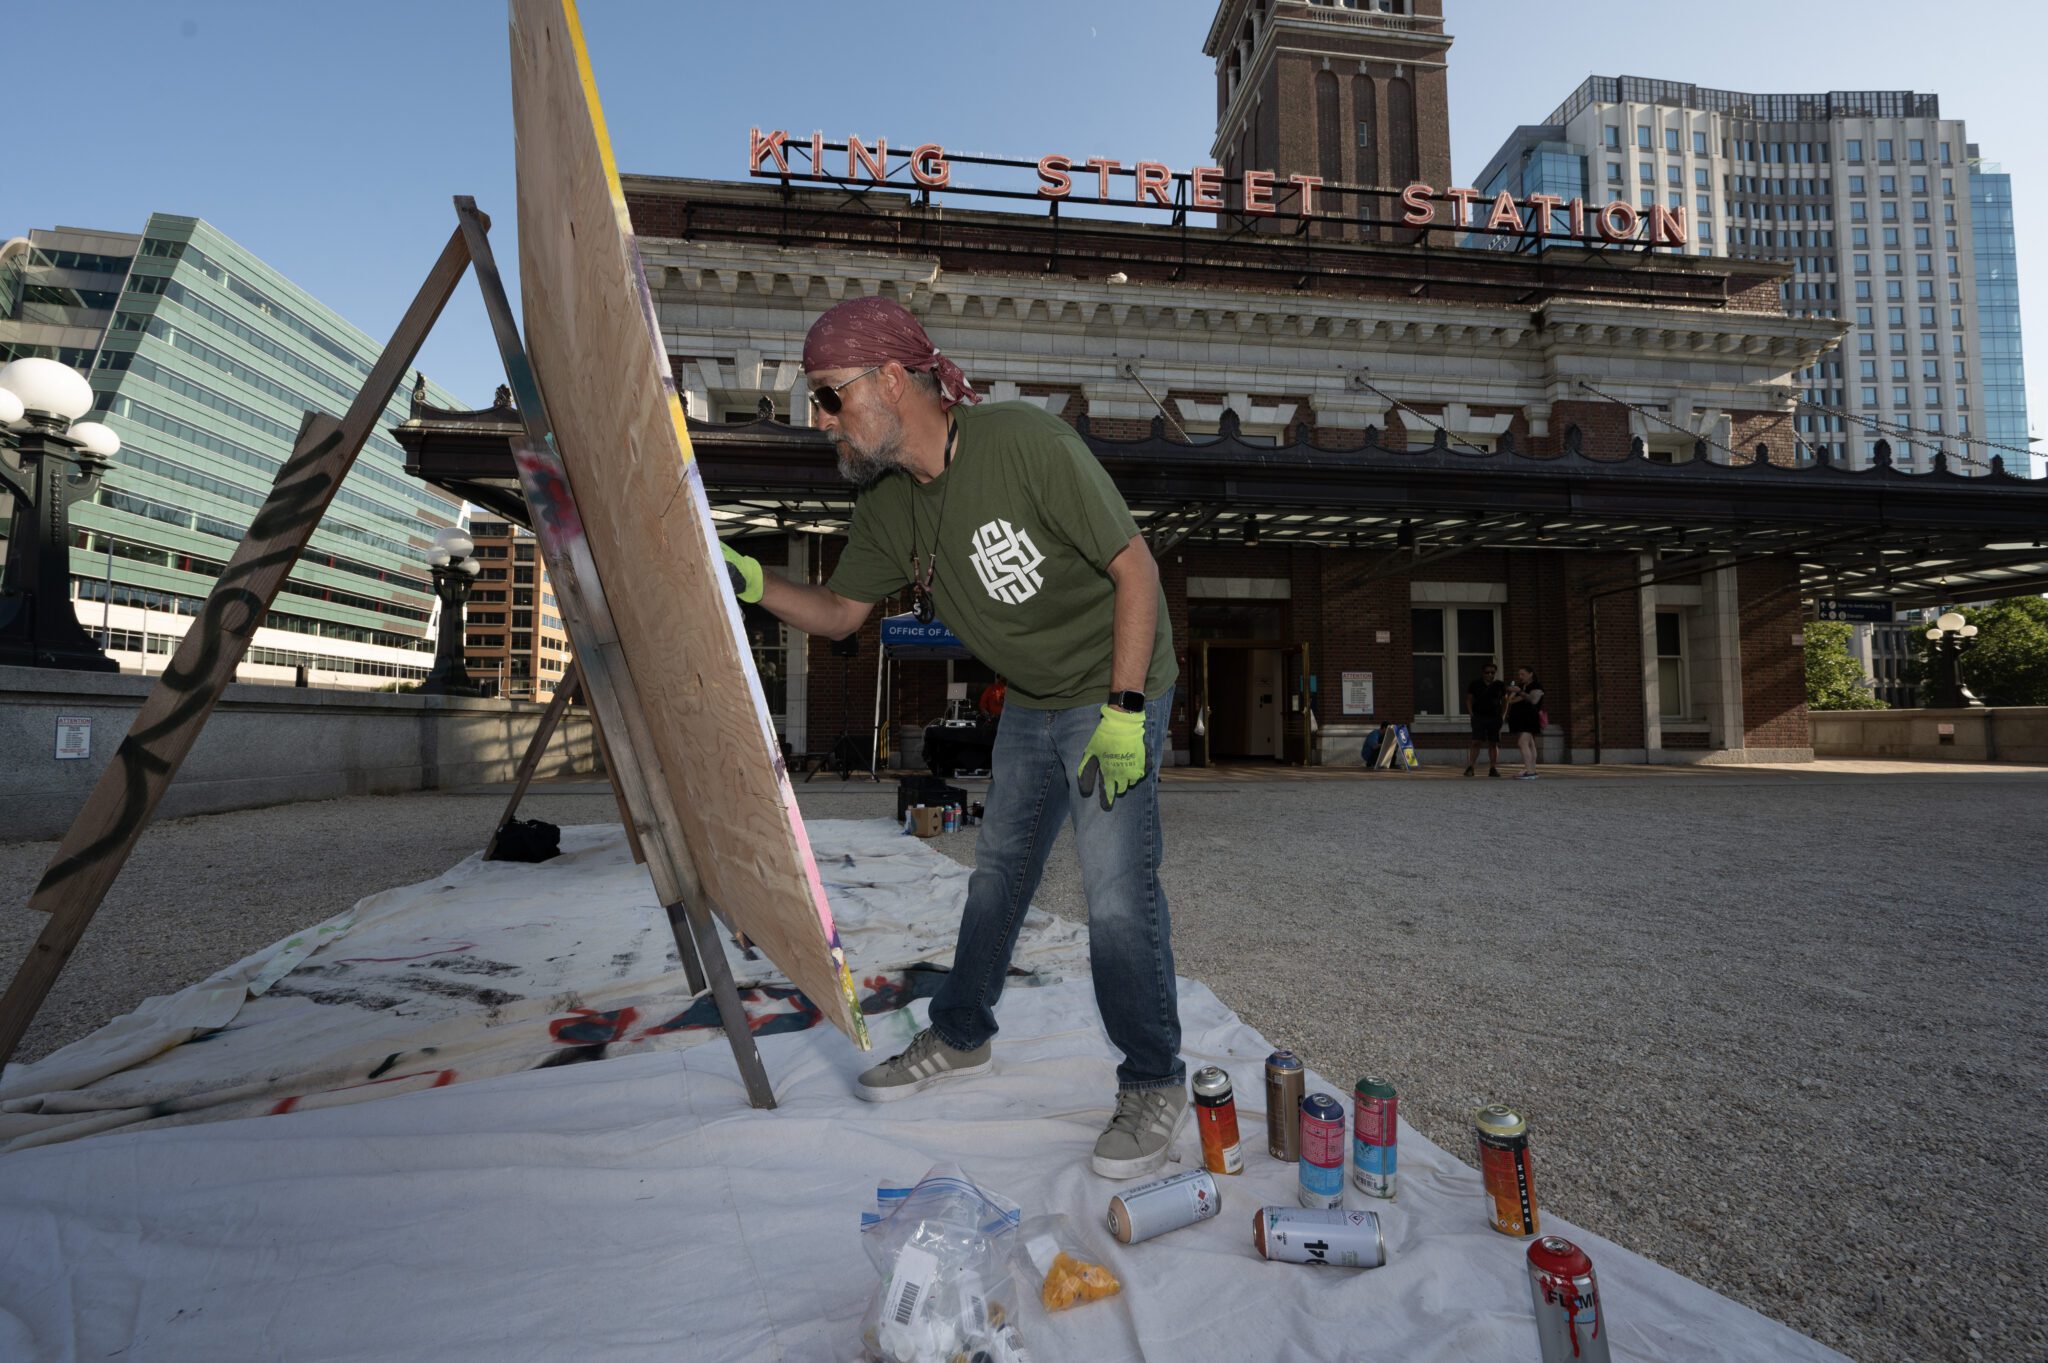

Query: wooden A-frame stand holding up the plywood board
[0,196,774,1107]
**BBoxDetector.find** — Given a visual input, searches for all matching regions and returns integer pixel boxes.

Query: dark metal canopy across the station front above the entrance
[401,403,2048,606]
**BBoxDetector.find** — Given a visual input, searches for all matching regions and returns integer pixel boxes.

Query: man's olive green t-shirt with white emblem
[827,403,1180,710]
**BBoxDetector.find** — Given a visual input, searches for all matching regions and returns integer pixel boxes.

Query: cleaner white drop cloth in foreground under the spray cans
[0,980,1841,1363]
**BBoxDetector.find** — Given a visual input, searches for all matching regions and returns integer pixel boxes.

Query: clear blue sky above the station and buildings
[0,0,2048,462]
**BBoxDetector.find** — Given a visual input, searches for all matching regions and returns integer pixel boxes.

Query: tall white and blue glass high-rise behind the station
[1477,76,2030,473]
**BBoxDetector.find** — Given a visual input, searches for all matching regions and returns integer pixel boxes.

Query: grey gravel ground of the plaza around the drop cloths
[0,772,2048,1363]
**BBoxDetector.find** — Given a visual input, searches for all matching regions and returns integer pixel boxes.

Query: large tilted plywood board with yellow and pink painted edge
[512,0,866,1048]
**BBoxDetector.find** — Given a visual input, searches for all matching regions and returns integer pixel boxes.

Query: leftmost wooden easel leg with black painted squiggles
[0,225,481,1064]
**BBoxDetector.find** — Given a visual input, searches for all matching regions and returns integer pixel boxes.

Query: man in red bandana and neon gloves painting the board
[727,297,1188,1179]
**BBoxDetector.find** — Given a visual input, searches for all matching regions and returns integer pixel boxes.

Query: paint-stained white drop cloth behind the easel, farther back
[0,821,1087,1146]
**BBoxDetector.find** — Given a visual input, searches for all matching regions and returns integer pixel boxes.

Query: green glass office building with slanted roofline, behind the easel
[0,213,461,688]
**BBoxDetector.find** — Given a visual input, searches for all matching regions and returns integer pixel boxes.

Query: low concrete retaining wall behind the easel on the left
[0,667,602,839]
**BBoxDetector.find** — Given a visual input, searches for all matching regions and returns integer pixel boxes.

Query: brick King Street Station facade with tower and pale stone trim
[610,0,1841,761]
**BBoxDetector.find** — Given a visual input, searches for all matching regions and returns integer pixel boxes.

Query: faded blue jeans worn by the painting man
[932,688,1186,1089]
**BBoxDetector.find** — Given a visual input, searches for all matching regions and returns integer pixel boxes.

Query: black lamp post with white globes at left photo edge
[0,358,121,671]
